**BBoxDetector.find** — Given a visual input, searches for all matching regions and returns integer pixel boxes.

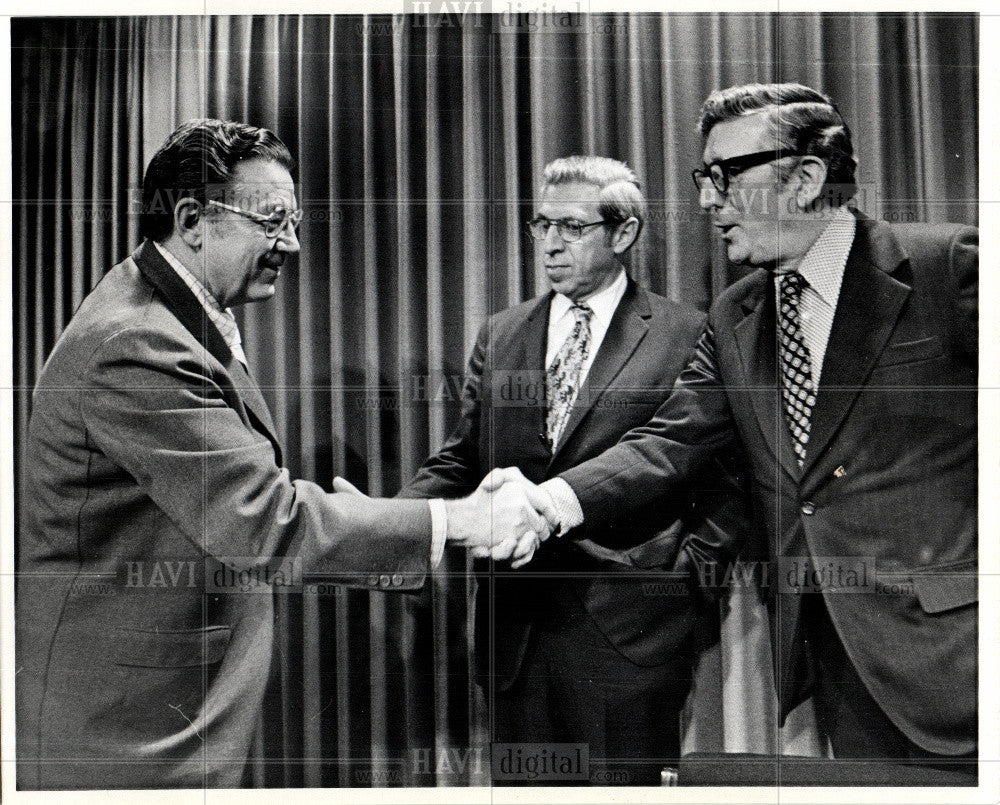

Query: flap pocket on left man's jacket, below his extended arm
[112,626,232,668]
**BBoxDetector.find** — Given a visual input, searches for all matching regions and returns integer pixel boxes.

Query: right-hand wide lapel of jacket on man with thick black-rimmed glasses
[803,216,910,471]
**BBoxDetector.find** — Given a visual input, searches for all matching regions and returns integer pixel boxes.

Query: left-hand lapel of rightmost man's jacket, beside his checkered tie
[733,271,799,478]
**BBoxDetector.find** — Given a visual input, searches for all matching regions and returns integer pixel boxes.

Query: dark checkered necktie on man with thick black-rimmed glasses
[778,272,816,469]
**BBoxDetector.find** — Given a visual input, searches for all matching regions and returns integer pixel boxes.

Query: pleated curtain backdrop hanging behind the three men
[12,13,978,786]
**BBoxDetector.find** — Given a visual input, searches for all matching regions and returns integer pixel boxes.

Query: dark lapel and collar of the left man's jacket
[132,240,281,456]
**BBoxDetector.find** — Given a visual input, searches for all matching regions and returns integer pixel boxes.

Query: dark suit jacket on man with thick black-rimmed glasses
[563,215,978,754]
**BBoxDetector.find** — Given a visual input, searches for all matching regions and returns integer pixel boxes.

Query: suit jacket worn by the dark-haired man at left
[16,243,430,789]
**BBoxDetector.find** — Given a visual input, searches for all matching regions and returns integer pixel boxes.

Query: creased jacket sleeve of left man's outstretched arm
[80,328,431,588]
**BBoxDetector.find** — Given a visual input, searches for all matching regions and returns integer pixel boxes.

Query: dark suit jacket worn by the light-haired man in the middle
[400,280,745,690]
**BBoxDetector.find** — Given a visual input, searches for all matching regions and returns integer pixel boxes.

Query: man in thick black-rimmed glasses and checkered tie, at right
[506,84,978,766]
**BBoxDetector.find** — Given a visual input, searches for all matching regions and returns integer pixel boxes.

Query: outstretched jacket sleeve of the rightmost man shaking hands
[560,318,735,528]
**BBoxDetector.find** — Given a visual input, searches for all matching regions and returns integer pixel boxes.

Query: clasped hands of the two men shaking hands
[333,467,560,568]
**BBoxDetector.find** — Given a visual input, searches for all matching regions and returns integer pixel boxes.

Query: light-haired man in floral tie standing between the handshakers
[401,156,744,785]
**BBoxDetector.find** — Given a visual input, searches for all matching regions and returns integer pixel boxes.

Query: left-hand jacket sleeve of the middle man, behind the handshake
[398,324,489,498]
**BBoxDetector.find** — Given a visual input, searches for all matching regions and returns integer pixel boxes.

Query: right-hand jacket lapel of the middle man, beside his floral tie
[552,279,652,459]
